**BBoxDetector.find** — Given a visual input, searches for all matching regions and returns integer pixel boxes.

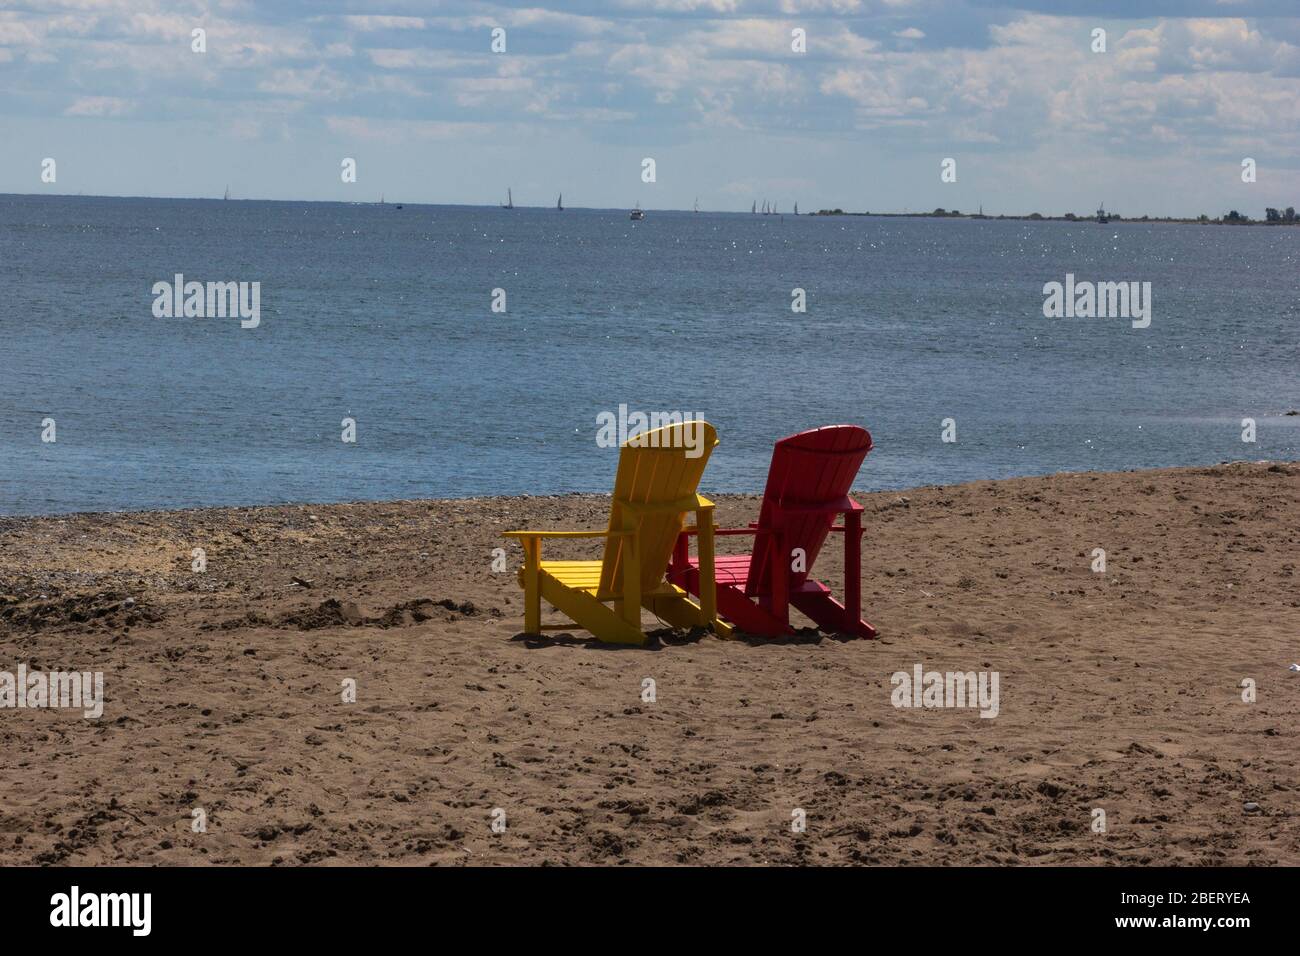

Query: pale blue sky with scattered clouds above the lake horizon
[0,0,1300,216]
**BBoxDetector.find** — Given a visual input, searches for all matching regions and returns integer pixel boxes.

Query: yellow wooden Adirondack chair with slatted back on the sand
[506,421,731,644]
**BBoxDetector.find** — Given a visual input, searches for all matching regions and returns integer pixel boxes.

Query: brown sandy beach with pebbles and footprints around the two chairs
[0,463,1300,865]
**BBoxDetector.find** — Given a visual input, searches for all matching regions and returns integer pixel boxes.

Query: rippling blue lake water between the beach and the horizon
[0,196,1300,514]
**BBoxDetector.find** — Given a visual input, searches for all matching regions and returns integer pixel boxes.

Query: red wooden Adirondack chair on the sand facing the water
[668,425,876,637]
